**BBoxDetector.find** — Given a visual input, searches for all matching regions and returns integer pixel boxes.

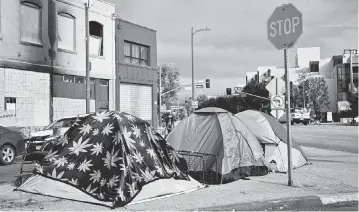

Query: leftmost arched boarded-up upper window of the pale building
[20,1,42,45]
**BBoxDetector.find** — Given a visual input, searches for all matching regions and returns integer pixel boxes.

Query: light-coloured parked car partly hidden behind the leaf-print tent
[31,114,88,150]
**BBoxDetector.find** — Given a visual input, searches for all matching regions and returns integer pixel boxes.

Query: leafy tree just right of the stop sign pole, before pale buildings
[305,77,329,117]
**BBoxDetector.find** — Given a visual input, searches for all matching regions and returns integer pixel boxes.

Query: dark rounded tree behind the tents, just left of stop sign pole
[243,79,270,110]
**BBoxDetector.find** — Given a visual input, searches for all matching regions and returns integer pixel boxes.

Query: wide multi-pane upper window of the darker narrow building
[124,41,150,66]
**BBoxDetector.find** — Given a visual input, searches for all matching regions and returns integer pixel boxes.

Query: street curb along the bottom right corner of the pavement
[192,193,358,211]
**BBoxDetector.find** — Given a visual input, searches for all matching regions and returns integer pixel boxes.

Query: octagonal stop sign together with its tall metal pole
[267,4,303,186]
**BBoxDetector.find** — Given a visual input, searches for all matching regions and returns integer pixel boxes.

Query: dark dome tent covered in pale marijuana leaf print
[18,111,202,207]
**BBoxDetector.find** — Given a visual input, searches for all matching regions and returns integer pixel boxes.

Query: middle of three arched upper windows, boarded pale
[57,13,76,51]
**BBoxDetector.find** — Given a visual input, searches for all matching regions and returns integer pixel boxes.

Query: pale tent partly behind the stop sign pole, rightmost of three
[236,110,308,172]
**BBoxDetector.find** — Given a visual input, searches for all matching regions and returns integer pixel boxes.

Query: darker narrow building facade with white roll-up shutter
[115,17,159,126]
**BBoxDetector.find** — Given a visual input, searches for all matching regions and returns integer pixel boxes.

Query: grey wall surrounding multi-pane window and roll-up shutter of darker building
[116,18,158,127]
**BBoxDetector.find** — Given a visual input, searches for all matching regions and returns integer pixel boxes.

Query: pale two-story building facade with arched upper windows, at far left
[0,0,116,127]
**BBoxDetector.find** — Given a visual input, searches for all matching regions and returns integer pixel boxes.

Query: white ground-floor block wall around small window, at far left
[0,68,50,127]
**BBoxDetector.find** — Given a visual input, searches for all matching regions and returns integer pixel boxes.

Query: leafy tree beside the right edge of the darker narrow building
[158,65,180,112]
